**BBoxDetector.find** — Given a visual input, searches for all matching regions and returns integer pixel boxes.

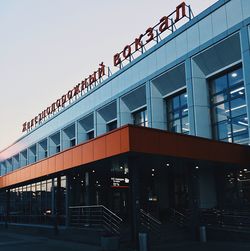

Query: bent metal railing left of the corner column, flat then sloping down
[69,205,122,235]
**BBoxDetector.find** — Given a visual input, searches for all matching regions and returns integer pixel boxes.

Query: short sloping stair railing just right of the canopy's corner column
[140,209,162,233]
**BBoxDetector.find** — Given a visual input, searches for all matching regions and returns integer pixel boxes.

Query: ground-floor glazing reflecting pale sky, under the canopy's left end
[0,176,66,224]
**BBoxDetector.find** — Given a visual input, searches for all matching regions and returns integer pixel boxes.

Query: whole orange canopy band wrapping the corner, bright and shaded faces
[0,125,250,188]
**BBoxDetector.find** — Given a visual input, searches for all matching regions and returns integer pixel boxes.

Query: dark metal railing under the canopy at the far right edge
[201,209,250,230]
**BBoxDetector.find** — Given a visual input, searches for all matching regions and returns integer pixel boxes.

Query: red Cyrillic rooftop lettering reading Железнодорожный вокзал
[22,2,192,132]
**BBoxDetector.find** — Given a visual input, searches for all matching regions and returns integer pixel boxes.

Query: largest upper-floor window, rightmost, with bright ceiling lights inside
[210,68,248,144]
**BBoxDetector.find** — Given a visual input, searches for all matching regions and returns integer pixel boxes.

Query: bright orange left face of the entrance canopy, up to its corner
[0,127,129,188]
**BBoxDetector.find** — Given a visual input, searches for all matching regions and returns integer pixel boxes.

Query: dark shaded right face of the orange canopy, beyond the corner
[129,127,250,165]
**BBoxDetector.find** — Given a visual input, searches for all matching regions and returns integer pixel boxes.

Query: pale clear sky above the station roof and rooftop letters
[0,0,216,150]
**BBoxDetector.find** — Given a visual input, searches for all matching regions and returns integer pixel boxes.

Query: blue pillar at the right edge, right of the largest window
[240,26,250,143]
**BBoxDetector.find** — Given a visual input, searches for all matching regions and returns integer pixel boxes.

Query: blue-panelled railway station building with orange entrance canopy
[0,0,250,243]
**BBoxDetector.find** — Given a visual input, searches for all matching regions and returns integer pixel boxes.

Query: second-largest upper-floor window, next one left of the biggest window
[166,91,189,134]
